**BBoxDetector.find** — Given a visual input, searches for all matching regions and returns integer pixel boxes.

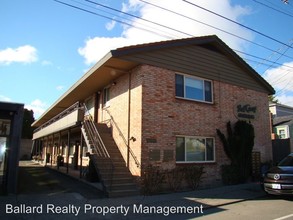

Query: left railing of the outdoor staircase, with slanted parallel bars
[83,104,110,158]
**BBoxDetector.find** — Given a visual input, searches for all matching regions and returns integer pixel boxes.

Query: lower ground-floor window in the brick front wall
[176,137,215,162]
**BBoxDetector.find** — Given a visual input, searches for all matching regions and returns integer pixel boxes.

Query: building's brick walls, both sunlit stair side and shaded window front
[99,65,272,186]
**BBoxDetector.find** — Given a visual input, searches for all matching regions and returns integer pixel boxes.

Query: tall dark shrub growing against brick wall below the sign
[217,120,254,183]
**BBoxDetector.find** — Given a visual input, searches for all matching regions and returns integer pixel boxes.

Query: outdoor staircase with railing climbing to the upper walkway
[82,120,139,197]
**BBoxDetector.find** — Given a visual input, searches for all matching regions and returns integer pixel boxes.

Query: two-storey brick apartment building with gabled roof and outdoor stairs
[33,36,274,197]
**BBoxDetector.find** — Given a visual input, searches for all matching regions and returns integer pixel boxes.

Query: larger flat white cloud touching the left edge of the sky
[0,45,38,65]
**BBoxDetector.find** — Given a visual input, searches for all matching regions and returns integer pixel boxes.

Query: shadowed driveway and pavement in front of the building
[0,161,272,220]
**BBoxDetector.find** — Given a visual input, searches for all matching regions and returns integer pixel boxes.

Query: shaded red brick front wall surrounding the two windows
[137,65,271,186]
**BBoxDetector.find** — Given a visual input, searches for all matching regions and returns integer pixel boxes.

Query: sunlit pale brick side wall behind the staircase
[99,70,143,176]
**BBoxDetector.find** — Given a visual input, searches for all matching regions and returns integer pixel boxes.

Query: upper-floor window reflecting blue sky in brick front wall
[175,74,213,102]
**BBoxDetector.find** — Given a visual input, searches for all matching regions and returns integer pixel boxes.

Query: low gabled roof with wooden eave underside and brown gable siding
[33,35,275,126]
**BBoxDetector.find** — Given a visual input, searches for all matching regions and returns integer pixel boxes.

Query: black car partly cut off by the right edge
[263,153,293,195]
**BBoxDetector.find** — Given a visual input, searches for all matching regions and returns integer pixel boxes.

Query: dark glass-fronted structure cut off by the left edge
[0,102,23,194]
